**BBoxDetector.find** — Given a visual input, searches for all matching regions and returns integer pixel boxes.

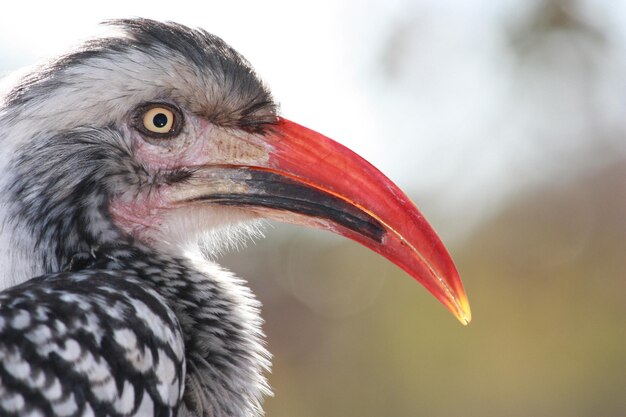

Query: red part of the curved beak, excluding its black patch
[259,118,471,324]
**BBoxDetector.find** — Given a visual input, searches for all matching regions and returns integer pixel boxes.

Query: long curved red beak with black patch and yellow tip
[176,118,471,324]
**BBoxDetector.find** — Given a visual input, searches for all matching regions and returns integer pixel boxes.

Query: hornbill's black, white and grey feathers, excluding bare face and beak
[0,19,275,417]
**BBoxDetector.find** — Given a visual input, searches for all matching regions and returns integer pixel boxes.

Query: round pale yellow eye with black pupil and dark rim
[135,103,182,138]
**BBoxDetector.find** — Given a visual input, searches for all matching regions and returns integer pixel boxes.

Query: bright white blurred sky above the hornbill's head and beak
[0,0,626,237]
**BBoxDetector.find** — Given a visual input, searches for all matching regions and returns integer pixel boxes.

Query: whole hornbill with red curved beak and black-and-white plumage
[0,18,471,417]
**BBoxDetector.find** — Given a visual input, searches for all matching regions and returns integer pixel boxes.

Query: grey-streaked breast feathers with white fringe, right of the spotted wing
[74,240,270,417]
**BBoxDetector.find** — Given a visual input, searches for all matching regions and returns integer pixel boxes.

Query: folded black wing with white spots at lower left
[0,269,185,416]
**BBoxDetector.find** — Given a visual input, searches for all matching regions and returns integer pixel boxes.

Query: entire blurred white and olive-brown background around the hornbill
[0,0,626,417]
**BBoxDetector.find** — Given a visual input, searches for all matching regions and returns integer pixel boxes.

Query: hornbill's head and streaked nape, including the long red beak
[0,19,470,324]
